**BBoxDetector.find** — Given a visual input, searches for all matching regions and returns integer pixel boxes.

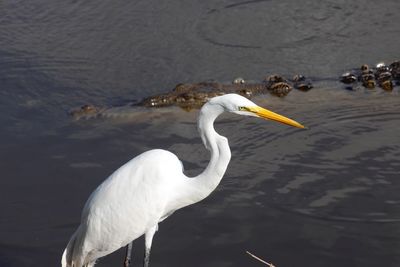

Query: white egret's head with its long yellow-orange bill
[210,94,305,129]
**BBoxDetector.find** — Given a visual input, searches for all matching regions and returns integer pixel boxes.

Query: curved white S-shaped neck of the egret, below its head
[187,103,231,204]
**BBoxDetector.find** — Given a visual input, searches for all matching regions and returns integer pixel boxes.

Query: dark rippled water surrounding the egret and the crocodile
[0,0,400,267]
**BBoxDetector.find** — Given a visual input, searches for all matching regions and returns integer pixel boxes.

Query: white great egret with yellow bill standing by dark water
[61,94,304,267]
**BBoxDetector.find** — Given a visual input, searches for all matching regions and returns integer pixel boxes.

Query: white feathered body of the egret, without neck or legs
[62,149,183,266]
